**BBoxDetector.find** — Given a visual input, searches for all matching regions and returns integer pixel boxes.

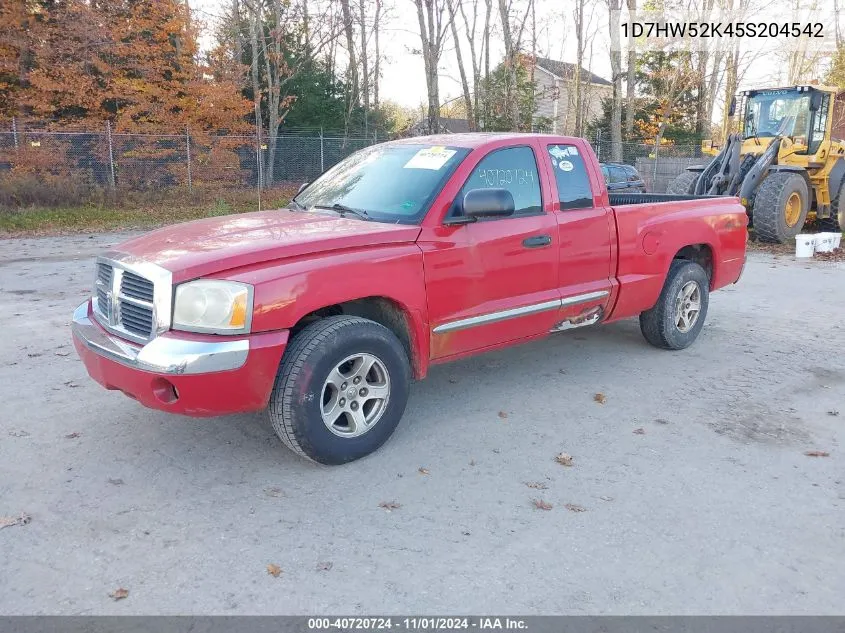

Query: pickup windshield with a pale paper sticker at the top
[294,144,469,224]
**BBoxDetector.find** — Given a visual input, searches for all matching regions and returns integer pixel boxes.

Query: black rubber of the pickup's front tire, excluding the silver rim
[268,316,411,465]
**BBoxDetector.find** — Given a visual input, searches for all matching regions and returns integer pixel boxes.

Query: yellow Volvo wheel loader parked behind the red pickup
[668,85,845,243]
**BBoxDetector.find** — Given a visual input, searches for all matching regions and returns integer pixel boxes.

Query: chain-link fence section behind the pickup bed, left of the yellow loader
[592,134,712,193]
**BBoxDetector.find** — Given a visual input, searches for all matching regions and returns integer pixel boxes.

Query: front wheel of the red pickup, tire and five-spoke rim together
[268,316,411,465]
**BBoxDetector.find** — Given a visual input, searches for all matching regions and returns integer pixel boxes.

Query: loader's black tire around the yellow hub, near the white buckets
[752,171,810,244]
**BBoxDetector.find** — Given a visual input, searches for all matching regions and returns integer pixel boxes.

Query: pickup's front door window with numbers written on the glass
[458,147,543,219]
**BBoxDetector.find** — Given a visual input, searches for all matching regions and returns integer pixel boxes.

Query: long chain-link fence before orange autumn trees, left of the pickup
[0,121,385,208]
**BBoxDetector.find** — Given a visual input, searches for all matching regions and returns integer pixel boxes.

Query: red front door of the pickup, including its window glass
[418,145,560,360]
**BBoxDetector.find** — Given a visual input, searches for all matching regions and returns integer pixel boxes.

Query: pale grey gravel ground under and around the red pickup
[0,234,845,614]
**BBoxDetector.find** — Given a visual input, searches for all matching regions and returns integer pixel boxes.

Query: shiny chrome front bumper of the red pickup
[72,302,249,375]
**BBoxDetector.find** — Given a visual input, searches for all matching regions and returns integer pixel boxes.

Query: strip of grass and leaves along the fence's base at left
[0,189,296,237]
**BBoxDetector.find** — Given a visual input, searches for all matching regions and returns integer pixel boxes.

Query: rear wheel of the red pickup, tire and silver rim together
[640,259,710,350]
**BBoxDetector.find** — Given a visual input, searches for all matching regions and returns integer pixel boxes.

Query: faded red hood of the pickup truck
[114,209,420,283]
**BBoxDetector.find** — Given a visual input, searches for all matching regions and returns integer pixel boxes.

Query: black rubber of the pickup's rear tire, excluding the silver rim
[640,259,710,350]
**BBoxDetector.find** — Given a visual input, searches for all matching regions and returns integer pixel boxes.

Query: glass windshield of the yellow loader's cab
[744,89,810,138]
